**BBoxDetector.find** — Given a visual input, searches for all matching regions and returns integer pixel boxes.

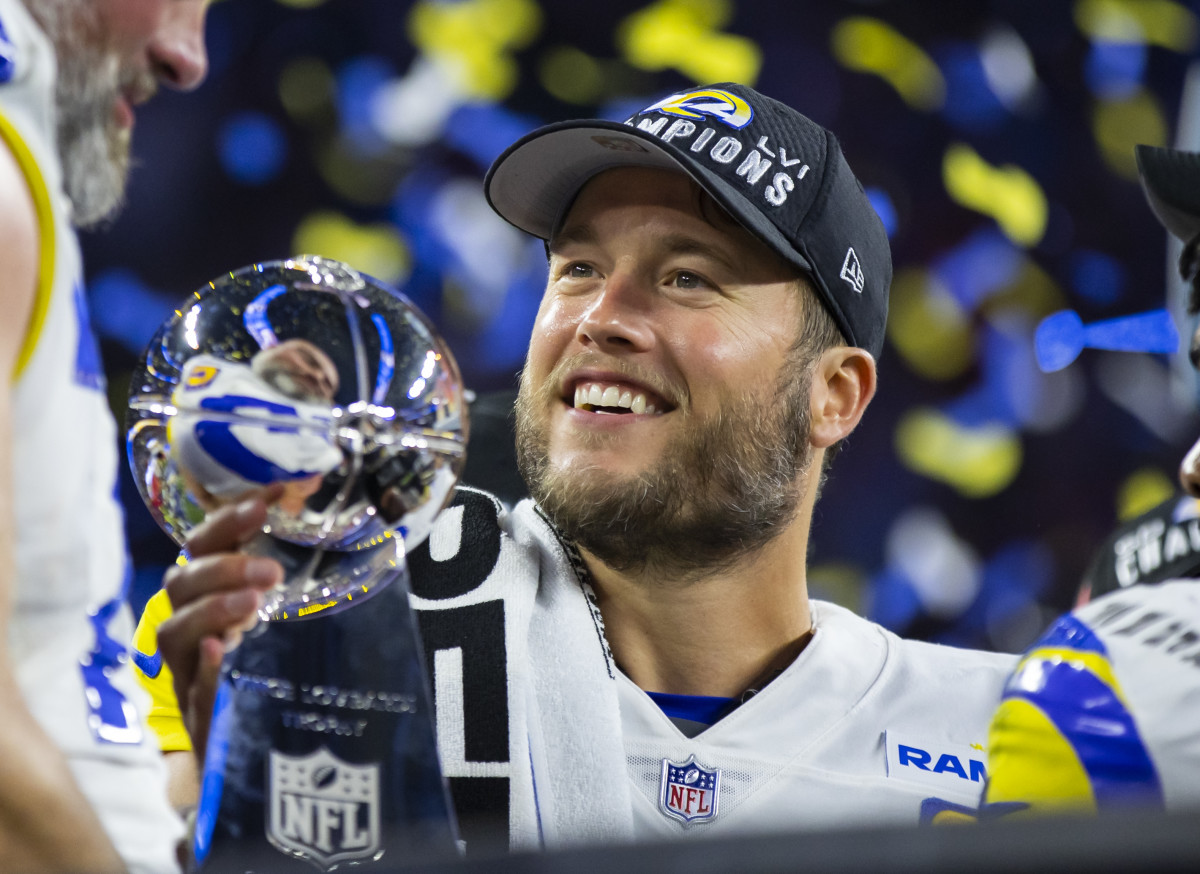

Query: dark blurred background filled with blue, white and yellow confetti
[96,0,1200,651]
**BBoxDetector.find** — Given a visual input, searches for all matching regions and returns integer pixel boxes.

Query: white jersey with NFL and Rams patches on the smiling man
[618,601,1015,838]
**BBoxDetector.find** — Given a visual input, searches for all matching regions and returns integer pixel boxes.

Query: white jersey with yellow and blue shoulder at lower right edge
[985,580,1200,815]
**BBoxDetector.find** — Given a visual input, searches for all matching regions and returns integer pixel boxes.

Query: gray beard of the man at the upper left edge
[24,0,130,228]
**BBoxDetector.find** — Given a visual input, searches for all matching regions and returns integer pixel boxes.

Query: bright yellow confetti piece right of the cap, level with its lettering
[942,143,1049,246]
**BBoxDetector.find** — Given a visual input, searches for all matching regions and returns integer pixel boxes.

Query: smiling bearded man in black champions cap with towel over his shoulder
[158,83,1013,851]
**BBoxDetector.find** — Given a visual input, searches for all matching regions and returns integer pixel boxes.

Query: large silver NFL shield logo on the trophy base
[266,747,379,872]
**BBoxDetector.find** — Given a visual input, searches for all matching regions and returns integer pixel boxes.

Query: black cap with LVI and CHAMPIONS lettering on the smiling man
[484,83,892,358]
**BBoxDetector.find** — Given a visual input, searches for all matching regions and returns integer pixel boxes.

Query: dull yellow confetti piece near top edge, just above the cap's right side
[830,16,946,112]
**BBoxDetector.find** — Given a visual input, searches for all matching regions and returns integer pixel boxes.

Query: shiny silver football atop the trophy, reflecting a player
[126,256,468,619]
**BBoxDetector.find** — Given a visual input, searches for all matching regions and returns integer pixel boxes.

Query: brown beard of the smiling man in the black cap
[516,353,812,580]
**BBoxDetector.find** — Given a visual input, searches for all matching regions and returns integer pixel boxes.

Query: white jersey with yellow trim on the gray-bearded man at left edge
[0,0,182,872]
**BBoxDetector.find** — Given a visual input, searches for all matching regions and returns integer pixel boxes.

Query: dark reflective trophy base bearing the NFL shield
[193,568,457,874]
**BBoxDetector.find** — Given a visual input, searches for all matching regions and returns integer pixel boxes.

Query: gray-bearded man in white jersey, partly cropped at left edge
[0,0,218,872]
